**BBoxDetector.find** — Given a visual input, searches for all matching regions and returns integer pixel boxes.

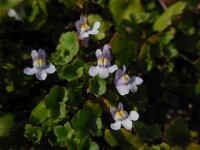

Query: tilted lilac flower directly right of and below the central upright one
[115,65,143,95]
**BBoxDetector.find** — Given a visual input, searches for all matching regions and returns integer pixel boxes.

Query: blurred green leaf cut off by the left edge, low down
[0,114,15,137]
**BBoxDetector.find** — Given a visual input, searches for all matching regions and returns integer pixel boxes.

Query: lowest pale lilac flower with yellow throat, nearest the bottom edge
[110,102,139,130]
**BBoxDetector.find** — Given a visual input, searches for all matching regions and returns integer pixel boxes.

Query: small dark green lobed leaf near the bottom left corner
[24,124,42,143]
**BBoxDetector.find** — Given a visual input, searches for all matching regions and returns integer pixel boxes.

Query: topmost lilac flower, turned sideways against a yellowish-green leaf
[75,17,101,40]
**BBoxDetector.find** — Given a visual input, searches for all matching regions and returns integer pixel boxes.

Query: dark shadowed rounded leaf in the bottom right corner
[165,118,190,147]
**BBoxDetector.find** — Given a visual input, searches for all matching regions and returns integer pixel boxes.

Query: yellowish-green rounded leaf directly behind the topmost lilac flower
[88,14,111,40]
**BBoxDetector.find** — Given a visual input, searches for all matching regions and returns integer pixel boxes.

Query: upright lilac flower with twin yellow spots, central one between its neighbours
[89,44,118,79]
